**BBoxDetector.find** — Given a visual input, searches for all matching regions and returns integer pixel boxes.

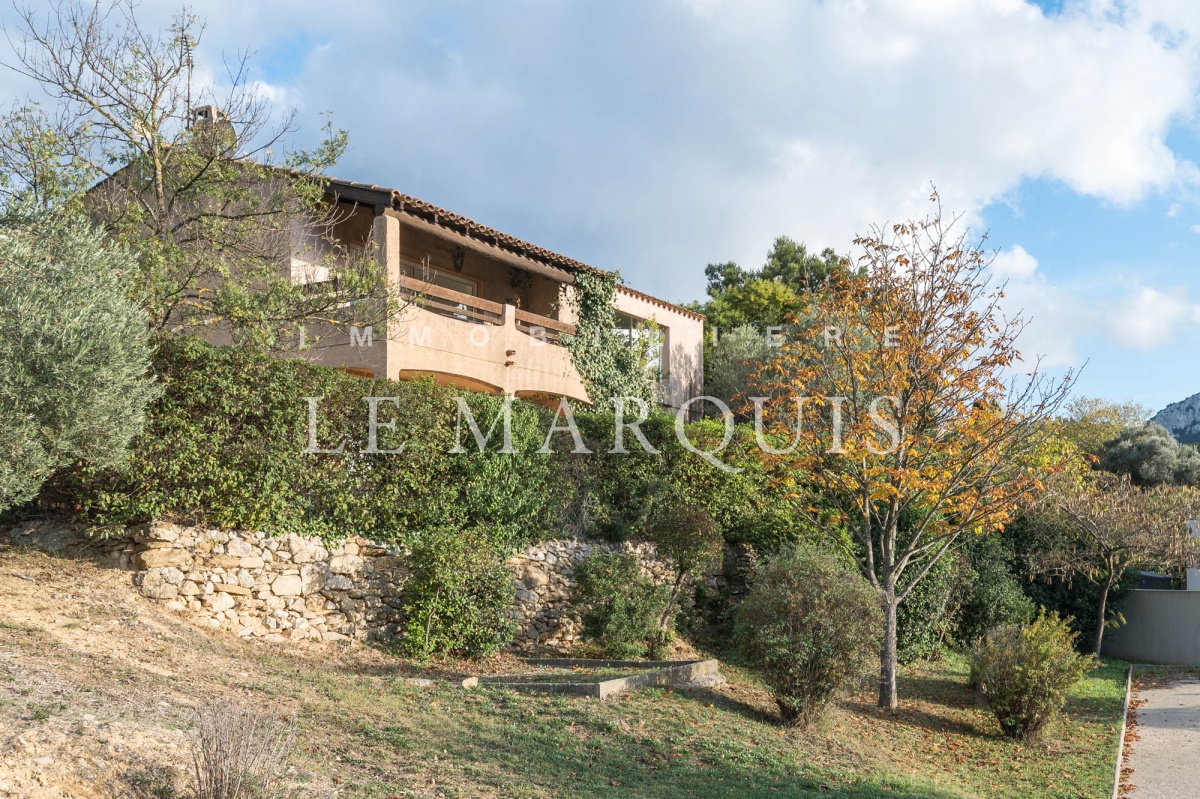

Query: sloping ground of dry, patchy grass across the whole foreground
[0,527,1123,799]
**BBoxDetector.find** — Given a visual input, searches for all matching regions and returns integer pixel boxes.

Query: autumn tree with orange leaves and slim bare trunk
[750,193,1072,709]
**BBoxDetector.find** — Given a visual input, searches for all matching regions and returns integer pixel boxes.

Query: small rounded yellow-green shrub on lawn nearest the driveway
[971,612,1094,740]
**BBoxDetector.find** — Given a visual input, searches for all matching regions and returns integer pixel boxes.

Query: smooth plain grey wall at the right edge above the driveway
[1103,589,1200,666]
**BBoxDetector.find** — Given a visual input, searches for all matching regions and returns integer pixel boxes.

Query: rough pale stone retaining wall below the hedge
[11,522,752,649]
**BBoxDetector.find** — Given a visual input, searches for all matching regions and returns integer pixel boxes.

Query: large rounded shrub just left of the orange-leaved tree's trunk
[734,547,882,727]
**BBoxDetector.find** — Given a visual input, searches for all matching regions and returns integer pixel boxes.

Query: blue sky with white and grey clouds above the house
[0,0,1200,409]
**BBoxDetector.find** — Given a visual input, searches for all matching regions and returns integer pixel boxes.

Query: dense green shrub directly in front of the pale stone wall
[401,530,516,657]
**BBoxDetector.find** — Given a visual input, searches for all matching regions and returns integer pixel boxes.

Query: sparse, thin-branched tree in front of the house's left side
[0,0,403,349]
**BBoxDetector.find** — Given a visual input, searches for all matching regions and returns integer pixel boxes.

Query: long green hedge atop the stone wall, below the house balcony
[49,328,805,549]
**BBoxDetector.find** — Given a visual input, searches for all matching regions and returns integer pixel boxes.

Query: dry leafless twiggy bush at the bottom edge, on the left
[191,702,295,799]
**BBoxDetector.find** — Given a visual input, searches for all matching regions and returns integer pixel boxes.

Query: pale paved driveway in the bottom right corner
[1128,678,1200,799]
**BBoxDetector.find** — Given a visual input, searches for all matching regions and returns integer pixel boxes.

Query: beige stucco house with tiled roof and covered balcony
[292,180,704,408]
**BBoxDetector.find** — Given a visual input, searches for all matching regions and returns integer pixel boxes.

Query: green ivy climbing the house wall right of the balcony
[564,272,661,409]
